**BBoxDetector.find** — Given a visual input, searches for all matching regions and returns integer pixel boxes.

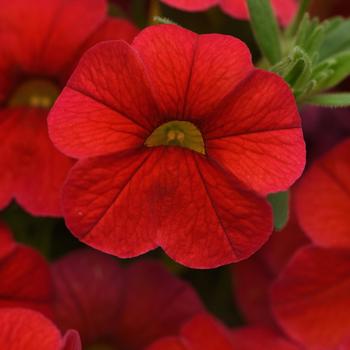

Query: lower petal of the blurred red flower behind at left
[4,108,73,216]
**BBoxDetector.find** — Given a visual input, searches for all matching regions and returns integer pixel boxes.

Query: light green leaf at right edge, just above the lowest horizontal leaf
[315,50,350,90]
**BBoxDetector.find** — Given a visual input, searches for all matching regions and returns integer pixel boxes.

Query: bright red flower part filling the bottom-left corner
[0,308,81,350]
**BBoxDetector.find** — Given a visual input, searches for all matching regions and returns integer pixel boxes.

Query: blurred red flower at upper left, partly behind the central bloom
[0,0,136,216]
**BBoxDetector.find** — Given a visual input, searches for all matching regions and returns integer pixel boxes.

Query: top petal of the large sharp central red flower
[133,25,253,120]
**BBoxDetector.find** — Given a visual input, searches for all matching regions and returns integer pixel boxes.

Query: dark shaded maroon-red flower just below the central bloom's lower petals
[53,250,203,350]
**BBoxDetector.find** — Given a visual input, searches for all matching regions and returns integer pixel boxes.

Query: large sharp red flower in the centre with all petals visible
[49,25,305,268]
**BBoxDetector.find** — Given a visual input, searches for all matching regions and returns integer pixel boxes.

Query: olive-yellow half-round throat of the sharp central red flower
[145,120,205,154]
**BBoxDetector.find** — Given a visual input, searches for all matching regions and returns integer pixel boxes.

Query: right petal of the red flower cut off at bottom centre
[232,327,302,350]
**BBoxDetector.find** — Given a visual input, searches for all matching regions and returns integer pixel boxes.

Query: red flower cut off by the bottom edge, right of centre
[147,314,299,350]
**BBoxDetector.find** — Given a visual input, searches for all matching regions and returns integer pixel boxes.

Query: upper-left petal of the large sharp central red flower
[49,41,158,158]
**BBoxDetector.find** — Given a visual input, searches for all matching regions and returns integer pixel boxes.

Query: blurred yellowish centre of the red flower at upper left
[8,79,60,108]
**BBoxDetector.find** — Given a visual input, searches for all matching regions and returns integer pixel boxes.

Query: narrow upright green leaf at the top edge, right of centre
[248,0,282,64]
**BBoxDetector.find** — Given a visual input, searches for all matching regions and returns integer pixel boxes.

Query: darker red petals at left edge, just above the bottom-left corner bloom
[0,223,53,318]
